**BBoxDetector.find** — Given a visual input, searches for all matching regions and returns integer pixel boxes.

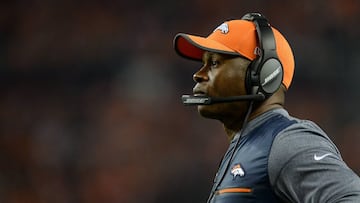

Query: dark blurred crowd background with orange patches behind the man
[0,0,360,203]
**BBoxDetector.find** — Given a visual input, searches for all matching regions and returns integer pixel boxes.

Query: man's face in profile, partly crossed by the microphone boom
[193,52,250,120]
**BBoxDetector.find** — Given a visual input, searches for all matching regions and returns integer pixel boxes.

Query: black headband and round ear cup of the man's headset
[241,13,284,99]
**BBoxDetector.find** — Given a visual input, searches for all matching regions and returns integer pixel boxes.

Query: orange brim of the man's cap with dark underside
[174,33,240,60]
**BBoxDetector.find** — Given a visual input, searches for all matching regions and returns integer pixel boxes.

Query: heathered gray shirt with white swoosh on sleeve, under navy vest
[253,109,360,203]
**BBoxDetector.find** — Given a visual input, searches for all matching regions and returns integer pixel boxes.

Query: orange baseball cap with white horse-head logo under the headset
[174,20,295,88]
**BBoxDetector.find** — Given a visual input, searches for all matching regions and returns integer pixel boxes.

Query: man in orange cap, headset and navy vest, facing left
[174,13,360,203]
